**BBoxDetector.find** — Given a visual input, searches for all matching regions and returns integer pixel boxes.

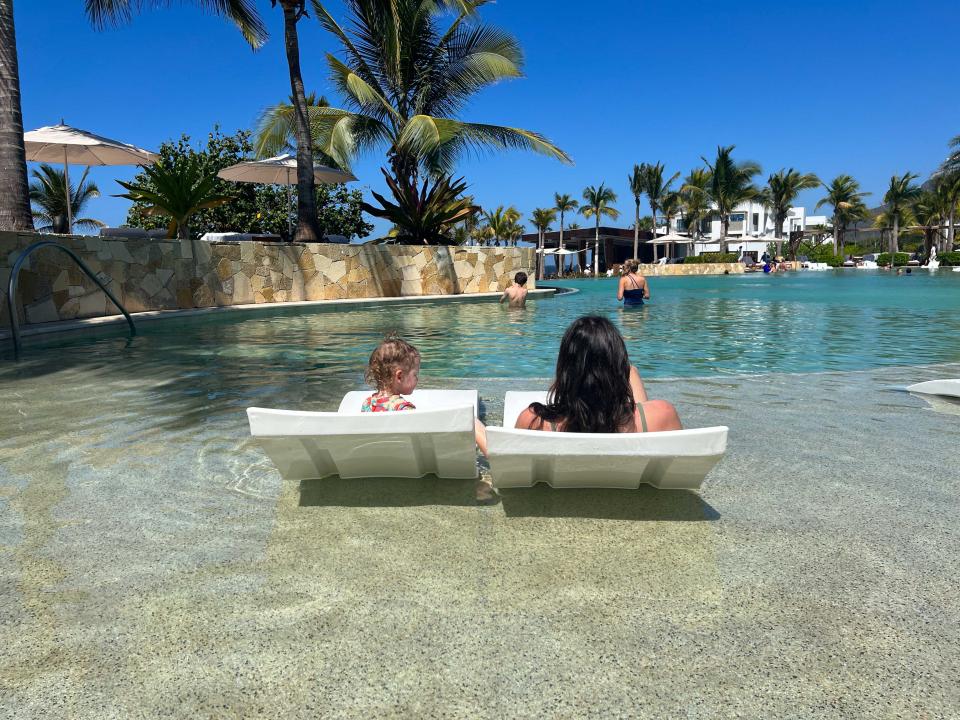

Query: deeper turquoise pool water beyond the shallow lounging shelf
[0,271,960,383]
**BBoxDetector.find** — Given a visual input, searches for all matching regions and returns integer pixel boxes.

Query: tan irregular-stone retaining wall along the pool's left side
[0,232,535,326]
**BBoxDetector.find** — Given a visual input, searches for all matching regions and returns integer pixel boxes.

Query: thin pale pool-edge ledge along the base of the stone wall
[0,288,557,340]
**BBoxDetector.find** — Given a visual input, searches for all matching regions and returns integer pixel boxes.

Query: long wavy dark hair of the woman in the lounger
[530,315,636,433]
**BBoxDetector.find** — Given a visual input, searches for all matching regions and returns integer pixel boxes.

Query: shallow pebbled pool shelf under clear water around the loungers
[0,363,960,718]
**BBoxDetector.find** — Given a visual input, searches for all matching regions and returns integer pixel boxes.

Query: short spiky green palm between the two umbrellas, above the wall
[116,155,233,239]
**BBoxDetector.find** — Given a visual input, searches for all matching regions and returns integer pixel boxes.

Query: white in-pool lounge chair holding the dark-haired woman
[487,392,727,490]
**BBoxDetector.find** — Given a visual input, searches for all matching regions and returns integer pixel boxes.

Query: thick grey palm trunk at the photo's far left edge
[0,0,33,230]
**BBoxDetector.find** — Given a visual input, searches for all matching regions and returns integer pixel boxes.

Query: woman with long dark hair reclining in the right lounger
[516,315,683,433]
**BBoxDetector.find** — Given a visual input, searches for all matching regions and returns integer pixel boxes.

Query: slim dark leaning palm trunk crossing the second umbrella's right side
[281,0,321,242]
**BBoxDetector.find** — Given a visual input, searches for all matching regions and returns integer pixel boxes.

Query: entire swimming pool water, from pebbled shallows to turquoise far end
[0,271,960,720]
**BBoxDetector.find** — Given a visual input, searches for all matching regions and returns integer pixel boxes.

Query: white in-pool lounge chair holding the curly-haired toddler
[247,390,477,480]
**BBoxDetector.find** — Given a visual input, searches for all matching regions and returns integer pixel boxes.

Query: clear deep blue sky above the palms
[15,0,960,236]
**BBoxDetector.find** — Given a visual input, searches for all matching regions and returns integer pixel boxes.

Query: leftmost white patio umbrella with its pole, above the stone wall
[23,120,158,232]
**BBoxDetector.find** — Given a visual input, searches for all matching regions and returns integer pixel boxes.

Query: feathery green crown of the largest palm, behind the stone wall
[258,0,570,191]
